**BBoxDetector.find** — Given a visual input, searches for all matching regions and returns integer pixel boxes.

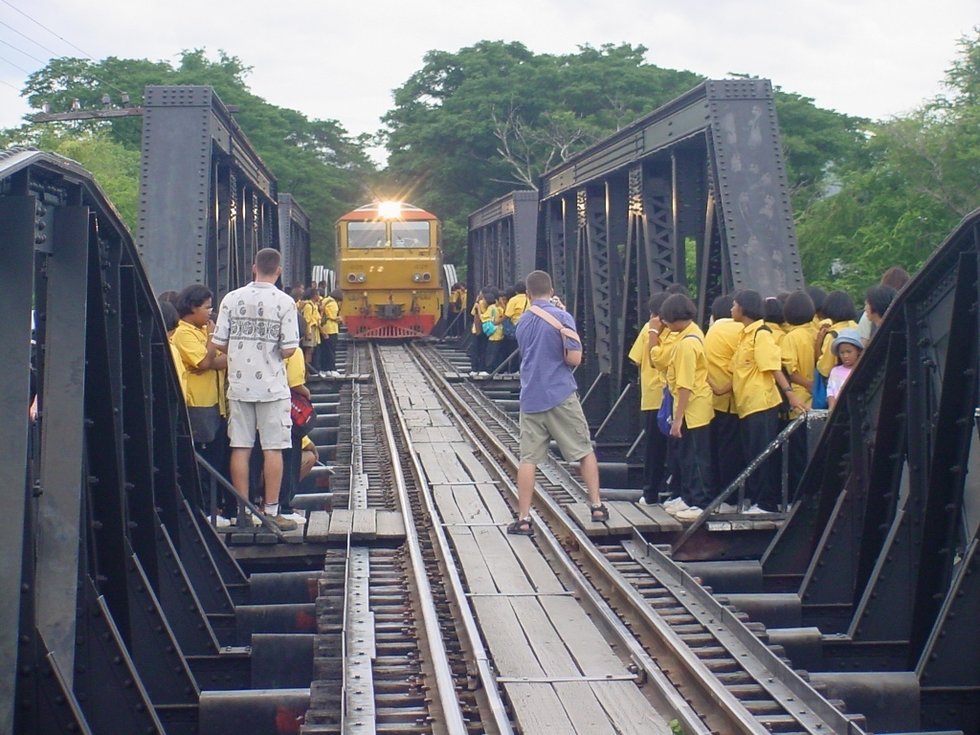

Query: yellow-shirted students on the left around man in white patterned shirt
[158,274,334,530]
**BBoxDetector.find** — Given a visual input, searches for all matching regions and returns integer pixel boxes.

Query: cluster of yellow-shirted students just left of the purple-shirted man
[466,281,531,378]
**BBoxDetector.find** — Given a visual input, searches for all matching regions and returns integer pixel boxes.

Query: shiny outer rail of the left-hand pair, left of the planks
[371,348,468,735]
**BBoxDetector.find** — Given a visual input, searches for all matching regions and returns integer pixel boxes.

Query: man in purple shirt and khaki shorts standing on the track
[507,271,609,536]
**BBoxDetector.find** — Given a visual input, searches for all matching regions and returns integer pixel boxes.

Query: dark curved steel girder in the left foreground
[0,152,248,734]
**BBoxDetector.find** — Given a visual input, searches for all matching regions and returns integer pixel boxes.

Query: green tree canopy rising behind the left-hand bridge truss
[7,49,375,263]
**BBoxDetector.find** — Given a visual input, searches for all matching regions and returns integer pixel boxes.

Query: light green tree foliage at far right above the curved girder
[797,32,980,297]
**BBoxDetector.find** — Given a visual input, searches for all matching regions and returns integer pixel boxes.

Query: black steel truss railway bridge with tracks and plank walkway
[0,77,980,735]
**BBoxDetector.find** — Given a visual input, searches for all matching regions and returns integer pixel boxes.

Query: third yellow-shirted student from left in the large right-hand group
[704,294,745,500]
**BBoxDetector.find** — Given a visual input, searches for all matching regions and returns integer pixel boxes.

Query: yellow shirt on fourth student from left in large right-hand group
[732,319,782,419]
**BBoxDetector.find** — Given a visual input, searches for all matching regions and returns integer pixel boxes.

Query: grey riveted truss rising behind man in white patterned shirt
[138,86,290,300]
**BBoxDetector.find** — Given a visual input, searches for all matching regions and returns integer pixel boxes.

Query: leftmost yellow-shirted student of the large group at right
[629,292,667,505]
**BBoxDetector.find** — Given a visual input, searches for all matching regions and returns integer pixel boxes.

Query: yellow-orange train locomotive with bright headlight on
[337,202,446,339]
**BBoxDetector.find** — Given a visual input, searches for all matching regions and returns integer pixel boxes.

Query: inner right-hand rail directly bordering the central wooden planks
[415,348,708,735]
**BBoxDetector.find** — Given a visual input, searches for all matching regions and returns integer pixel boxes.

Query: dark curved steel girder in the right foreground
[762,210,980,730]
